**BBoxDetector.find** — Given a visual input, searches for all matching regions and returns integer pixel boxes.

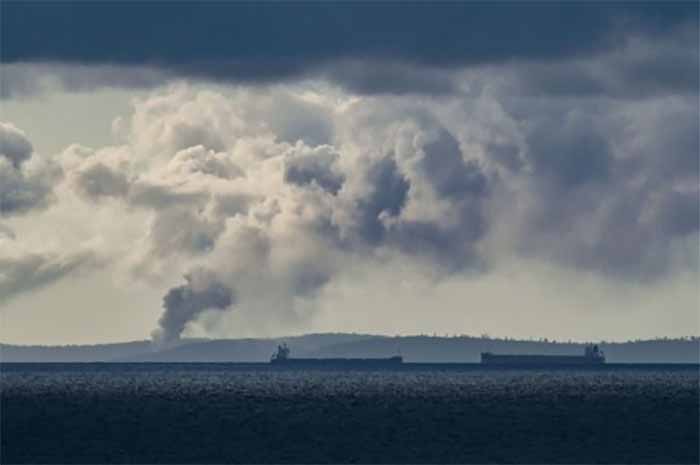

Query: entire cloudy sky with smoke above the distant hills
[0,1,700,346]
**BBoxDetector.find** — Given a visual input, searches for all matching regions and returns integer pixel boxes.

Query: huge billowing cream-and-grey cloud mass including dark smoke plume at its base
[8,76,699,343]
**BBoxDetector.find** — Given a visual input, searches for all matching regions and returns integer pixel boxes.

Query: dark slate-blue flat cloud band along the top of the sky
[2,2,698,94]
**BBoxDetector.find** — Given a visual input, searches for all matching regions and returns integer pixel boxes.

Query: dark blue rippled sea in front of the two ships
[0,364,700,463]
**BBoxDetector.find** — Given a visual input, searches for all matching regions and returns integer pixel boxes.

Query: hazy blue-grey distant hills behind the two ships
[0,333,700,363]
